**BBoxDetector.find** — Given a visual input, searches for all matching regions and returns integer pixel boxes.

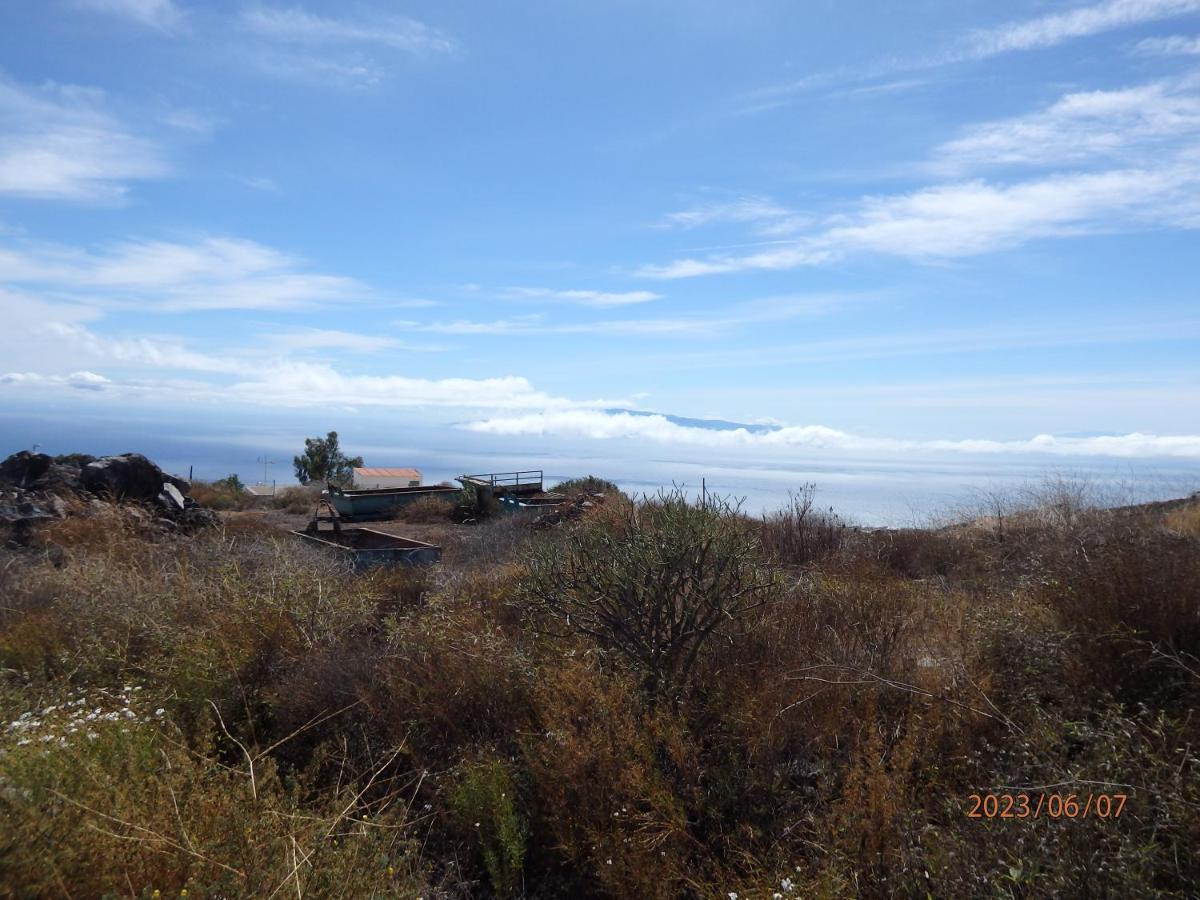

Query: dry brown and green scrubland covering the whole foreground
[0,486,1200,900]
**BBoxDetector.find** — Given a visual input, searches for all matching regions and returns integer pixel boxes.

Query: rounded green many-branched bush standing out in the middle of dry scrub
[526,491,776,696]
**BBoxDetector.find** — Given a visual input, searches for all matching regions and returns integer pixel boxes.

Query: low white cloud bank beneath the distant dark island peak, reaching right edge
[462,409,1200,460]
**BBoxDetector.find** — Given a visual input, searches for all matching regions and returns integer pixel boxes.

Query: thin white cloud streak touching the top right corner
[965,0,1200,58]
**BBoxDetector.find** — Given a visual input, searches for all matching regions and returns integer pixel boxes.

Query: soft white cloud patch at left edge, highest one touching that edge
[0,78,172,202]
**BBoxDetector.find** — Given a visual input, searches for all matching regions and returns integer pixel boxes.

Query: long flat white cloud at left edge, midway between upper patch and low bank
[0,238,372,312]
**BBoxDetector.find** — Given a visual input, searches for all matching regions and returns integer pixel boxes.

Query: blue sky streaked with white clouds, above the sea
[0,0,1200,504]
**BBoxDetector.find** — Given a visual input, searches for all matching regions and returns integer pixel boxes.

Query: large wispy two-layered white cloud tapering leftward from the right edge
[640,78,1200,278]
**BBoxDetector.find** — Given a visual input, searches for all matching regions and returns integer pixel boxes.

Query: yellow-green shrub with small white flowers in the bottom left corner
[0,686,425,898]
